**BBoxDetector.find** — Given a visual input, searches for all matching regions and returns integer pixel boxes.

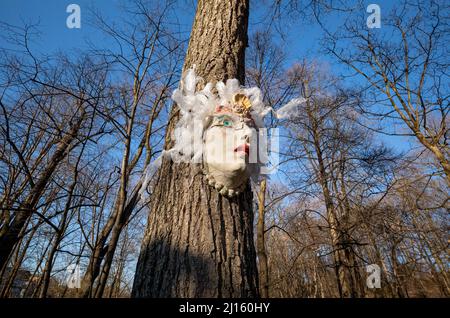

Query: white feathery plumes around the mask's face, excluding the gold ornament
[140,67,305,197]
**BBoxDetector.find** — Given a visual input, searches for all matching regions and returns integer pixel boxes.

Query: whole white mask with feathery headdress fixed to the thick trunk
[139,67,304,197]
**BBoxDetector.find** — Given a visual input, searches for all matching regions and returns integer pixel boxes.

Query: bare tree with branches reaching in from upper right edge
[327,0,450,184]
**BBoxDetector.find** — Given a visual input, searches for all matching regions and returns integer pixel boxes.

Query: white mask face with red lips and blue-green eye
[203,112,256,197]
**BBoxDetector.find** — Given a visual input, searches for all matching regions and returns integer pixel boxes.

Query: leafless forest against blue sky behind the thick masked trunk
[0,0,450,298]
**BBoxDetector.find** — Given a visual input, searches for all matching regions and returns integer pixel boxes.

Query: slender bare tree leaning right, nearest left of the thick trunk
[75,1,180,297]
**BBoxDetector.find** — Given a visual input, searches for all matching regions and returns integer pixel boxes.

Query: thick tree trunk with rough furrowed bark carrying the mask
[132,0,259,297]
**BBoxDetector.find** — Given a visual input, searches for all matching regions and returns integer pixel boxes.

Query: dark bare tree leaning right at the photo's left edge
[0,28,109,274]
